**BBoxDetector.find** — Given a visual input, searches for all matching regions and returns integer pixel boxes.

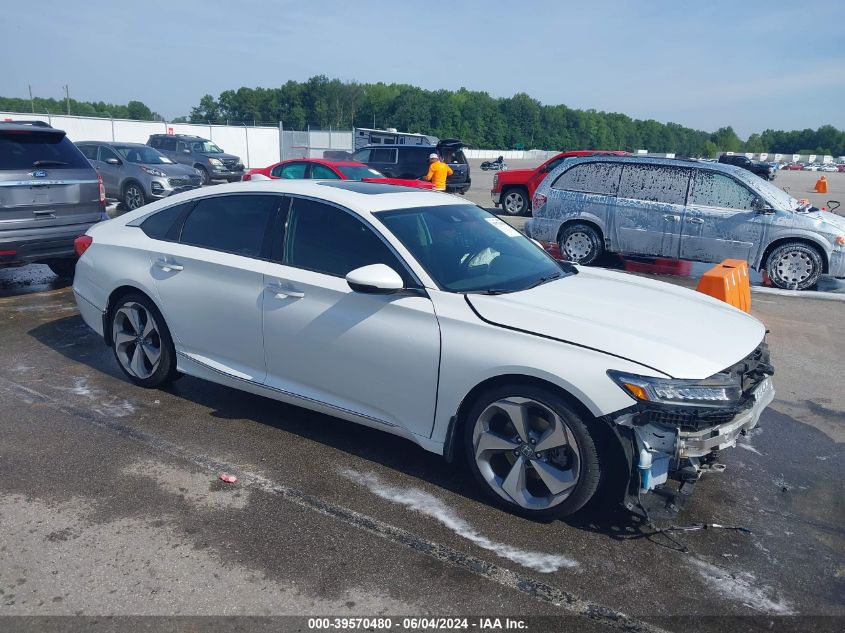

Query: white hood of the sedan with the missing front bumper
[467,268,766,379]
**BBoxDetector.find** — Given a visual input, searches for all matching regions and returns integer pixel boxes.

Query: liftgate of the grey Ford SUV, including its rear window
[0,128,102,229]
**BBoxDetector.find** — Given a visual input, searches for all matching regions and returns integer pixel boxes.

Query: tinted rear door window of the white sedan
[179,195,281,257]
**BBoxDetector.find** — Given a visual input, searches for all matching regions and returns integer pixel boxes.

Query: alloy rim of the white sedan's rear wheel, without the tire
[112,302,161,380]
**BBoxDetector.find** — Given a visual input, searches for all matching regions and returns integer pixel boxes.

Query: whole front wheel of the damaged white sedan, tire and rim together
[464,384,601,520]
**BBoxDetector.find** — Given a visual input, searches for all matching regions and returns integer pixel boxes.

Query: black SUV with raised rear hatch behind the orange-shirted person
[352,139,472,194]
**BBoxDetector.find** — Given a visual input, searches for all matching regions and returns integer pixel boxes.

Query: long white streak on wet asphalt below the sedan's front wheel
[340,468,578,573]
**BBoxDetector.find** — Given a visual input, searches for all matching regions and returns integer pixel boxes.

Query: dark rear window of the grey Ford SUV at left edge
[0,129,93,171]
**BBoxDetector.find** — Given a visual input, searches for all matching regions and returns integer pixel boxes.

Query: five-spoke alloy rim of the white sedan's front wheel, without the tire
[473,397,581,510]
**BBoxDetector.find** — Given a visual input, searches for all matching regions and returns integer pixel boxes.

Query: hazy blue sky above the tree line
[0,0,845,137]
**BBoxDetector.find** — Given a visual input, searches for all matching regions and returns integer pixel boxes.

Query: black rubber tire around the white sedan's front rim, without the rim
[462,384,602,521]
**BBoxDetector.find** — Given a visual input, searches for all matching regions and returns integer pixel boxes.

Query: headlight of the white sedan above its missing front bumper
[607,370,742,407]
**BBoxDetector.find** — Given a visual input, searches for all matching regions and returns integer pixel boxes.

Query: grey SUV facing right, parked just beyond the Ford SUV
[76,141,202,211]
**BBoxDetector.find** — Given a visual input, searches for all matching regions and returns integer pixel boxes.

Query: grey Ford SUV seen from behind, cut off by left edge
[0,121,108,277]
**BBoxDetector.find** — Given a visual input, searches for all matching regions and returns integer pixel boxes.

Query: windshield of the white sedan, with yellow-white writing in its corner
[375,204,575,294]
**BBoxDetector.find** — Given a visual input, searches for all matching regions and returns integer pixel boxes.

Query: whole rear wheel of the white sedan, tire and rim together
[111,293,179,389]
